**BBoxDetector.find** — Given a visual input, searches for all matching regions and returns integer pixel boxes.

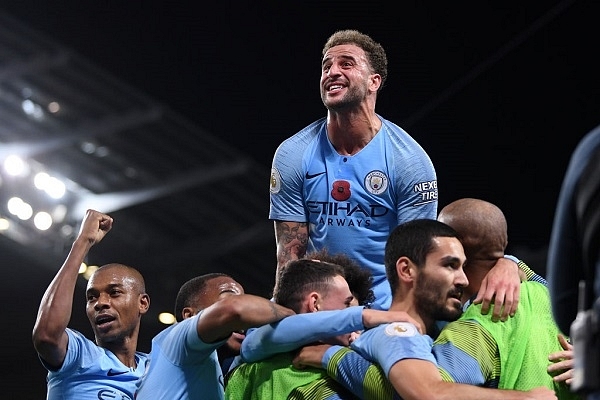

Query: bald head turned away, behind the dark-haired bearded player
[438,198,508,263]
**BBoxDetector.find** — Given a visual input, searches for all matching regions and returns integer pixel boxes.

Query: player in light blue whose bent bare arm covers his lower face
[136,273,294,400]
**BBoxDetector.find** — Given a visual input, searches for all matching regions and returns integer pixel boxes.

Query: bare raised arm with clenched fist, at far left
[33,210,113,368]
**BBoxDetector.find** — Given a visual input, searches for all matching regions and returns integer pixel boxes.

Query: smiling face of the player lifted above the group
[321,44,381,111]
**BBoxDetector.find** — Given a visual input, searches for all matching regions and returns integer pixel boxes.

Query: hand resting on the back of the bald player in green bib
[473,257,521,321]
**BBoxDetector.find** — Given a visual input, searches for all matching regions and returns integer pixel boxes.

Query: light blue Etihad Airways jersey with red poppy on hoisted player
[269,116,438,309]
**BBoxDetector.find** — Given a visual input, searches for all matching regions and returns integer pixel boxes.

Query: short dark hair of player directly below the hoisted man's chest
[273,258,345,313]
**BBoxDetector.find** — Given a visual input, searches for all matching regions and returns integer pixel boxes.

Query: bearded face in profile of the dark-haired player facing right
[414,237,469,321]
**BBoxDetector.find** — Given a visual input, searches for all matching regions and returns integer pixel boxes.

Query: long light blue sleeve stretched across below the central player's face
[240,306,364,362]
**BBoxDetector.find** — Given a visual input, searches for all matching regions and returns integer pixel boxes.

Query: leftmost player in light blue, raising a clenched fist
[32,210,150,399]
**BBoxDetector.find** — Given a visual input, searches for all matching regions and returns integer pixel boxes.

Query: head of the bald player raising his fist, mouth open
[86,264,150,347]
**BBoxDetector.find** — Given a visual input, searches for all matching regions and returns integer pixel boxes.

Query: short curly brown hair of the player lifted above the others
[322,29,387,91]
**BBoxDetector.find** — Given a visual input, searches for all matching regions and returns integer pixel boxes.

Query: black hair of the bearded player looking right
[385,219,458,296]
